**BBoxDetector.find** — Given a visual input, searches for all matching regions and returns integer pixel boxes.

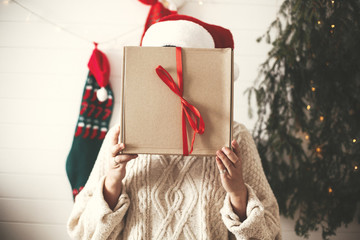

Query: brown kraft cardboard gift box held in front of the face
[120,47,233,156]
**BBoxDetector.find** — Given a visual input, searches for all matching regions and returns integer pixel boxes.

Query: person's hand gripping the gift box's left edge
[103,126,138,209]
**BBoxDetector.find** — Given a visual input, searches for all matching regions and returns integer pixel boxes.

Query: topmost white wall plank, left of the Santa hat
[0,0,149,25]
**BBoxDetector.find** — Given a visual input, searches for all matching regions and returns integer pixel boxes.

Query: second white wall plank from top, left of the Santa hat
[0,21,144,47]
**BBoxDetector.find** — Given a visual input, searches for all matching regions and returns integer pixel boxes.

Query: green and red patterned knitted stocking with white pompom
[66,44,113,199]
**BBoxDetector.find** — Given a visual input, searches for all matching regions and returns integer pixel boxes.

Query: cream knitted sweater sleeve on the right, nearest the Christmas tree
[220,124,281,240]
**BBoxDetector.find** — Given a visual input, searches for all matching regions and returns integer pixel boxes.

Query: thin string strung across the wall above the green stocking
[11,0,142,44]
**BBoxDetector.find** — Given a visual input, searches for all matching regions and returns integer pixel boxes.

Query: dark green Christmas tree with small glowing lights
[248,0,360,239]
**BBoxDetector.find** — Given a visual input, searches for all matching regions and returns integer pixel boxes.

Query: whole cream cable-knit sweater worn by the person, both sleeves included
[68,123,281,240]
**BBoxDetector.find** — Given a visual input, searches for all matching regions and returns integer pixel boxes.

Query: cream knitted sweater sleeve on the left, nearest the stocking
[67,126,130,240]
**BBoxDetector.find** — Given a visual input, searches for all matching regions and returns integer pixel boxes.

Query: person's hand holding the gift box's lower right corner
[216,140,247,221]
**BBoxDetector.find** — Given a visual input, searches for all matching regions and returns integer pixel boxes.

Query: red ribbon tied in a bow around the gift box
[156,47,205,156]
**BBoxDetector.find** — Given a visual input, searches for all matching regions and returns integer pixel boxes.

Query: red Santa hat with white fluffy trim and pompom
[140,14,239,79]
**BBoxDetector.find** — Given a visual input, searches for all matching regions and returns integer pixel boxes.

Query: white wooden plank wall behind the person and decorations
[0,0,360,240]
